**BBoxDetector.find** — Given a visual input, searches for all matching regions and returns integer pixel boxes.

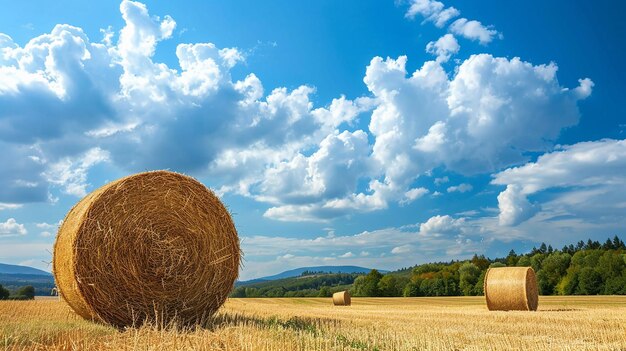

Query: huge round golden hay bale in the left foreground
[53,171,240,327]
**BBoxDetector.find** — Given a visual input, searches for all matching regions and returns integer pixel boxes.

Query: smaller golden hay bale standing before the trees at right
[484,267,539,311]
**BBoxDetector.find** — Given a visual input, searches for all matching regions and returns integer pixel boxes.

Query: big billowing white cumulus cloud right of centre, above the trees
[356,54,592,214]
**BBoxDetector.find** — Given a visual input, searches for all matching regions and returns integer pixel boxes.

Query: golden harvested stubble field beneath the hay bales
[0,296,626,350]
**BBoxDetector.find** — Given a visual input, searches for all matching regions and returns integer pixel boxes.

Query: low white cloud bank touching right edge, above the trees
[492,139,626,225]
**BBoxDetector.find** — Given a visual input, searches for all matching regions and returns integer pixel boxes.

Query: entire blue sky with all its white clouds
[0,0,626,279]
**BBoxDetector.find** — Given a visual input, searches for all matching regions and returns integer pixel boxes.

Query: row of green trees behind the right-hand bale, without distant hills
[351,236,626,296]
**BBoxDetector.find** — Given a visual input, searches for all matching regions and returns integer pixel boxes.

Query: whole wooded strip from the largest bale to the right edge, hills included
[231,236,626,297]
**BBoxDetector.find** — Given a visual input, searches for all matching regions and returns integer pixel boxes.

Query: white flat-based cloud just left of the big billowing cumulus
[257,130,375,220]
